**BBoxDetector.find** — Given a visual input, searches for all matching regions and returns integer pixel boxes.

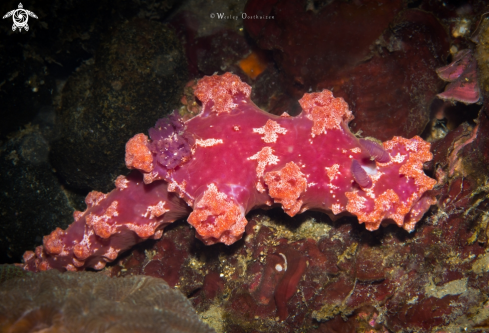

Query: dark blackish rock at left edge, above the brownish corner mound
[0,125,81,263]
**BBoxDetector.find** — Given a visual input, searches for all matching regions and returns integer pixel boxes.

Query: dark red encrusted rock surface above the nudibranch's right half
[245,1,449,140]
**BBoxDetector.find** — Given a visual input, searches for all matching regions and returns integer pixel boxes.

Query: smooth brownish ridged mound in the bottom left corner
[0,271,214,333]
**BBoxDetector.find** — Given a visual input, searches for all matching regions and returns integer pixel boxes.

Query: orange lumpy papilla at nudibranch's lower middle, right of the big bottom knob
[264,162,307,216]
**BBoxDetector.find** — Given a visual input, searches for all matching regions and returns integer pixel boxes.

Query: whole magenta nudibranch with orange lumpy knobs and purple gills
[21,73,436,270]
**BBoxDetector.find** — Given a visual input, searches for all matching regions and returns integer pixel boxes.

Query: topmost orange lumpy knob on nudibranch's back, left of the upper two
[194,73,251,114]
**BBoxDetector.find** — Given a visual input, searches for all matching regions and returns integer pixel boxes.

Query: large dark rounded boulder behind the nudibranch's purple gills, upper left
[51,19,187,191]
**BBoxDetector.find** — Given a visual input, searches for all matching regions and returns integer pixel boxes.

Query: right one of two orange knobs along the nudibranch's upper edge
[299,90,354,136]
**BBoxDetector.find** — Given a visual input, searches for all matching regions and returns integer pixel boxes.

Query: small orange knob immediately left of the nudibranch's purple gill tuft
[126,133,153,172]
